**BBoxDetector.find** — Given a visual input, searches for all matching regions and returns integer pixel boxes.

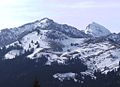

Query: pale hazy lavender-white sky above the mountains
[0,0,120,32]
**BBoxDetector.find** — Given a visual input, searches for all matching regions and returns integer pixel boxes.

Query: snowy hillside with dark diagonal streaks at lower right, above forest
[62,42,120,73]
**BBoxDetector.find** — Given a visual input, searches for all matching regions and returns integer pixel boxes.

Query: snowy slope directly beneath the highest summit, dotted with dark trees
[6,30,85,59]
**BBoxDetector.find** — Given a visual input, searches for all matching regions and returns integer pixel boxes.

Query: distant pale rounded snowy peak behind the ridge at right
[85,22,111,37]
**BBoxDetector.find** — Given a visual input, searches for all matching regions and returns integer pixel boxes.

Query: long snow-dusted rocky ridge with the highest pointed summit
[0,18,88,47]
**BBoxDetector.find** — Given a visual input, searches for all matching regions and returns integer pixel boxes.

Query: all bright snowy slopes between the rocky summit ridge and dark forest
[5,30,120,73]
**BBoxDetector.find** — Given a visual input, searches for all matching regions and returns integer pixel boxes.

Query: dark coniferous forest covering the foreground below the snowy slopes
[0,47,120,87]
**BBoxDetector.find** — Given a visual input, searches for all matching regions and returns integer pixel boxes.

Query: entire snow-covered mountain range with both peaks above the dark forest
[0,18,120,85]
